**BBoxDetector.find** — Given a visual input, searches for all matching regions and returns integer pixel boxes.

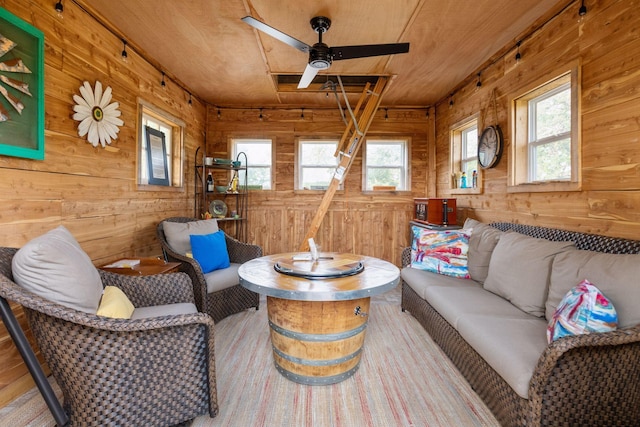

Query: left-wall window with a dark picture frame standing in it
[138,100,184,187]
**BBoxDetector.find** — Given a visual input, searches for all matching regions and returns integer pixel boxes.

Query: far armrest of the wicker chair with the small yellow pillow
[100,270,195,307]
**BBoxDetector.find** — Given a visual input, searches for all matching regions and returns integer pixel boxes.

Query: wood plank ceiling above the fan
[75,0,564,108]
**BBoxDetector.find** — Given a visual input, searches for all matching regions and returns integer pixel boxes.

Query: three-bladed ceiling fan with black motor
[242,16,409,89]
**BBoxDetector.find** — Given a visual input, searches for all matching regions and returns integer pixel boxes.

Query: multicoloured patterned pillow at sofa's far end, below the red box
[411,225,471,279]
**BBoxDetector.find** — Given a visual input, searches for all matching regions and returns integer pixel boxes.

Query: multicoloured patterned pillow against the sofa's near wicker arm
[547,280,618,343]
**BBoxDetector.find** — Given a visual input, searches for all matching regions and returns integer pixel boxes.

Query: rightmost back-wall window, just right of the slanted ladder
[364,139,411,191]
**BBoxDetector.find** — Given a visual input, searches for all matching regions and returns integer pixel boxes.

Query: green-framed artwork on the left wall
[0,8,44,160]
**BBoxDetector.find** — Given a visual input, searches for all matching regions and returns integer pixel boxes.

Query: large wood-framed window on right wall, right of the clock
[508,67,580,191]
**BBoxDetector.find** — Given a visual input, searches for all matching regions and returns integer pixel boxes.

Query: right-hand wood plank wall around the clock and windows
[435,0,640,239]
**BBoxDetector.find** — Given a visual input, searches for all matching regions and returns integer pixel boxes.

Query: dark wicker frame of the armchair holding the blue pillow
[157,217,262,322]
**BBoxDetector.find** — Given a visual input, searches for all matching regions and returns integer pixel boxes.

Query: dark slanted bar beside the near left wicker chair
[0,297,69,427]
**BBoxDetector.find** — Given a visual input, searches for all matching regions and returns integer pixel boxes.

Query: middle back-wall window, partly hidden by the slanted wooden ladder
[297,139,338,190]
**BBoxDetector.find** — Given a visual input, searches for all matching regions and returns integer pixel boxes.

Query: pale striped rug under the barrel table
[0,298,499,427]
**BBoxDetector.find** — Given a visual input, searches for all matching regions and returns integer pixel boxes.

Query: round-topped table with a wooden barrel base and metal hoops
[238,252,400,385]
